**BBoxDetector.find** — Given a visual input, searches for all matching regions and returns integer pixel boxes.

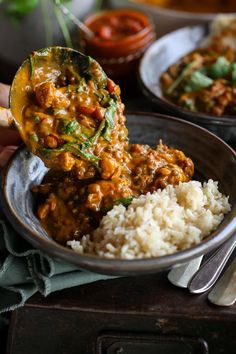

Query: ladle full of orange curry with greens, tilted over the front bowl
[6,47,127,179]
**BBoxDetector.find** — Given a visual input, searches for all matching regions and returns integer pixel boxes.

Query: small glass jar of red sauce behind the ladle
[84,9,156,92]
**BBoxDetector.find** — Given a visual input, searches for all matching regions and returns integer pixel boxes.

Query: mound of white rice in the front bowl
[67,180,231,259]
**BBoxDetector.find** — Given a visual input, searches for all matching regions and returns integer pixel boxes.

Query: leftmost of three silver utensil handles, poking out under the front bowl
[167,256,203,288]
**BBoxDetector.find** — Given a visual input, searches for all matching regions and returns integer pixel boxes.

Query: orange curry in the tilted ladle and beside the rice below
[13,48,194,244]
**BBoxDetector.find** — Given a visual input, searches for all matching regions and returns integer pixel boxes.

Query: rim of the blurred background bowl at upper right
[138,25,236,126]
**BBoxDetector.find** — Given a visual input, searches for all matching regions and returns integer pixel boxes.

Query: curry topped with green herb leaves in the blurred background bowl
[160,17,236,116]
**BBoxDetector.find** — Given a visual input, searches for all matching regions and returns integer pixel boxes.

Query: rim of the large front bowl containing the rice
[0,111,236,276]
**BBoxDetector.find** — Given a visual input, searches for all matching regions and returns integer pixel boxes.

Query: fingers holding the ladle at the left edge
[0,83,20,167]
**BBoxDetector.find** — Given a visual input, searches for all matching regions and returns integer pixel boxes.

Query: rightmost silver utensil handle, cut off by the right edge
[208,258,236,306]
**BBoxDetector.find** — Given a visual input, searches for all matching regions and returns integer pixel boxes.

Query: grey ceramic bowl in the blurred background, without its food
[139,26,236,143]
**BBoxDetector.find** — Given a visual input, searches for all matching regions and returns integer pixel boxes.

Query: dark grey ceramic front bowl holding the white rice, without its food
[1,113,236,275]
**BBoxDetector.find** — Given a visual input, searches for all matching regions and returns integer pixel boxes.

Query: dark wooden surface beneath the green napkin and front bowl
[7,272,236,354]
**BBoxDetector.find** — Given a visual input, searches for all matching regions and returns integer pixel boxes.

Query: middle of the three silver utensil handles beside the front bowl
[188,233,236,294]
